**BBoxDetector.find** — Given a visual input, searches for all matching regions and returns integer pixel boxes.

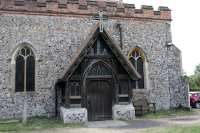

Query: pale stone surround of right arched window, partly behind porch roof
[127,46,148,92]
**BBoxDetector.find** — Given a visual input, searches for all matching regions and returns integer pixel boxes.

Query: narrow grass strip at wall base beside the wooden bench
[136,109,197,119]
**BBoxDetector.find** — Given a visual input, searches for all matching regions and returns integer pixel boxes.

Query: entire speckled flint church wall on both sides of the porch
[0,14,188,119]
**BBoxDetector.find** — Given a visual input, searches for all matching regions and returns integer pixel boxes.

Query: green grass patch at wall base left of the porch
[0,117,82,132]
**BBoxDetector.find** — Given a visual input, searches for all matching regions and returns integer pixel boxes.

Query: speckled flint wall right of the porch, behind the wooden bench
[104,20,170,110]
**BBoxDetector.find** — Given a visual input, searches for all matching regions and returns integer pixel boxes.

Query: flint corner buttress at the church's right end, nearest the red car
[168,45,190,108]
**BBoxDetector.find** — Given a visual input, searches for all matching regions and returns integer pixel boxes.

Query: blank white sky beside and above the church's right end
[123,0,200,75]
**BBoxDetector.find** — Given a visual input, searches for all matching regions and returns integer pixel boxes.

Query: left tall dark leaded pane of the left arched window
[15,56,24,92]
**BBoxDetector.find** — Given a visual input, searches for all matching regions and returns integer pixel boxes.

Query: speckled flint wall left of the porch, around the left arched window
[0,14,97,119]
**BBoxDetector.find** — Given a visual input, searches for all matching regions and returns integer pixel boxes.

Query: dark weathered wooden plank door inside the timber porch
[87,80,112,121]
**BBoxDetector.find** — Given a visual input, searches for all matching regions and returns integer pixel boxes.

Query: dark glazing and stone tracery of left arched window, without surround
[15,47,35,92]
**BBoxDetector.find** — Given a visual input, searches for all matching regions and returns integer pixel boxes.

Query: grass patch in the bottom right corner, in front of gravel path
[144,124,200,133]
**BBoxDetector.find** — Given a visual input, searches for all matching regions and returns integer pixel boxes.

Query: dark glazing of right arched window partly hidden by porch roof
[129,49,144,89]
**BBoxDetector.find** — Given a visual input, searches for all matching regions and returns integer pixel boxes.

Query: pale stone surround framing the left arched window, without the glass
[11,43,39,95]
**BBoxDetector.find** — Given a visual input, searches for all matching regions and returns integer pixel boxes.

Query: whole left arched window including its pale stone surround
[11,43,38,93]
